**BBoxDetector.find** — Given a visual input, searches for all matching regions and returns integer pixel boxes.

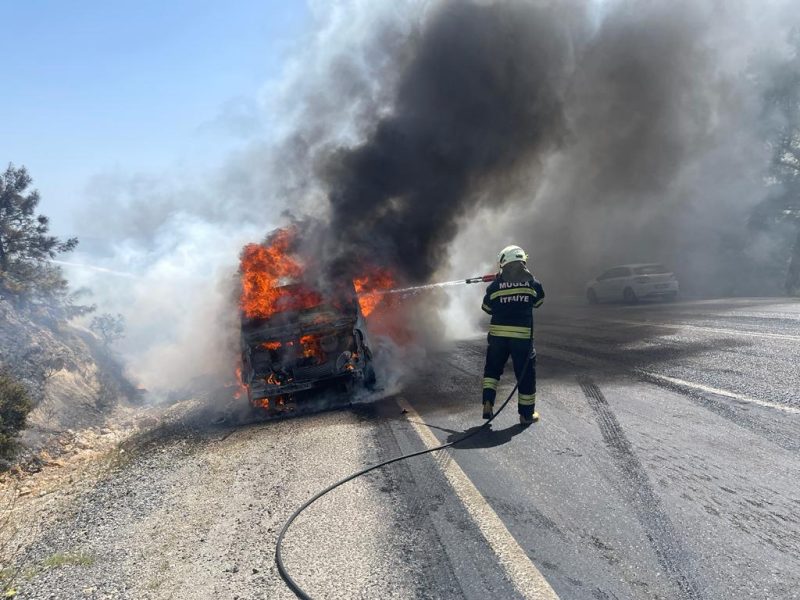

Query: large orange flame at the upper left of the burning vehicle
[239,228,322,319]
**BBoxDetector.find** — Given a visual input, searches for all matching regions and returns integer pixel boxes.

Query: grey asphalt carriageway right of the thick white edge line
[387,299,800,599]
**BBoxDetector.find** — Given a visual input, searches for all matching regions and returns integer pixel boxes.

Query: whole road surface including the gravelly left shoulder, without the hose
[12,299,800,600]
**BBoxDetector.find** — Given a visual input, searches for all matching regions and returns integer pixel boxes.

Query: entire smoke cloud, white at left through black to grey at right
[61,0,800,389]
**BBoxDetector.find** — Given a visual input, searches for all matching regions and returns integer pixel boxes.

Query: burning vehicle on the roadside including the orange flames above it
[240,228,385,415]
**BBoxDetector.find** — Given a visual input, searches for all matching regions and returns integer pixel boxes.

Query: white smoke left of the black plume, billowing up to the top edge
[63,0,427,396]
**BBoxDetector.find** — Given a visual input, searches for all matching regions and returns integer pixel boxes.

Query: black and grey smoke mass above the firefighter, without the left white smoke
[306,0,797,293]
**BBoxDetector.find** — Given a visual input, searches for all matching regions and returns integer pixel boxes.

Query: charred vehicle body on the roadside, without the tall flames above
[241,283,375,414]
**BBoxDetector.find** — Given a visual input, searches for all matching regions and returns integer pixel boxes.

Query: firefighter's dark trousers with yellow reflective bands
[483,334,536,417]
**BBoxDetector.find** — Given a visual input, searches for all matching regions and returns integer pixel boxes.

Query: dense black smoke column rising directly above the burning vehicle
[324,2,570,282]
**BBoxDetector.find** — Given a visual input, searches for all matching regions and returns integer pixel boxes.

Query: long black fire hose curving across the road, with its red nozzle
[275,275,533,600]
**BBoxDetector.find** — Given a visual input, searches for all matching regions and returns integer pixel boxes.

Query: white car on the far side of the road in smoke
[586,263,678,304]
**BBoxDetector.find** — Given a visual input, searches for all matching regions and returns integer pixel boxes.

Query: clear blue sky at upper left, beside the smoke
[0,0,310,234]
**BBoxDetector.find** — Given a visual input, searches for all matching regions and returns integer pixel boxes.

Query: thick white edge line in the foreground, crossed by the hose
[398,398,558,600]
